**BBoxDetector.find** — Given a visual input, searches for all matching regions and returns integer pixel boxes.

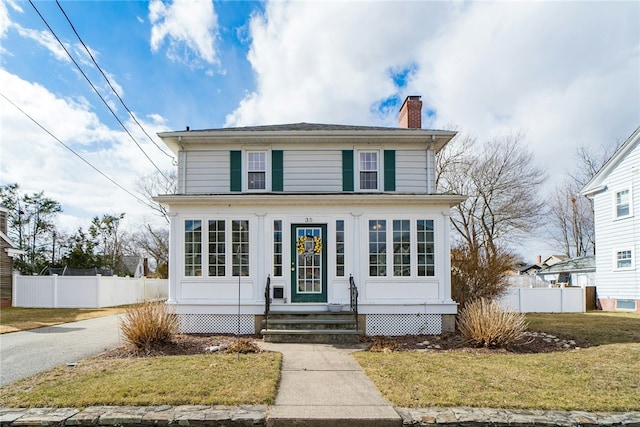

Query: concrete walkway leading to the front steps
[261,343,402,427]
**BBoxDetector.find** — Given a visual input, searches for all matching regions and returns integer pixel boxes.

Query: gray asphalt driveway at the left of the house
[0,315,123,386]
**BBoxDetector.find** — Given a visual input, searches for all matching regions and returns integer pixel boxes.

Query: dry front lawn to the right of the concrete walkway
[355,313,640,412]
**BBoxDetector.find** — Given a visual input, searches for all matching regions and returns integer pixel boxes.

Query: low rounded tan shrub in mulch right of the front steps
[458,298,527,347]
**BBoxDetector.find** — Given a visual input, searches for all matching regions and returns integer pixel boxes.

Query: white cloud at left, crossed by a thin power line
[0,69,171,231]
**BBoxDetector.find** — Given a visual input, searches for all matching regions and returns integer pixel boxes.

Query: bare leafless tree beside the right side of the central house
[438,134,546,256]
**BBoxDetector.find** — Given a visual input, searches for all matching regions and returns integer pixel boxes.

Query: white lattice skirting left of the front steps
[178,314,255,335]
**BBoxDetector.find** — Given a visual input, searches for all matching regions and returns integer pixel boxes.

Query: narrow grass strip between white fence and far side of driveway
[0,306,127,334]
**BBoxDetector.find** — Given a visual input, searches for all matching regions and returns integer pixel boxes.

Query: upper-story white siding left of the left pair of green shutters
[185,150,230,194]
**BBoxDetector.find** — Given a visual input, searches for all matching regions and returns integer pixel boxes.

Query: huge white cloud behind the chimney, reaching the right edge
[226,2,640,187]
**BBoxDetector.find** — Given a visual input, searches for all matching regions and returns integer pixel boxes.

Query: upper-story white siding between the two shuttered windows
[283,150,342,193]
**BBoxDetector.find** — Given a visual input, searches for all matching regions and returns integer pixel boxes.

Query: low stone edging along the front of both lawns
[0,405,640,427]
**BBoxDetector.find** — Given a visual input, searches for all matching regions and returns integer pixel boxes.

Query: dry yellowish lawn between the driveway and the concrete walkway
[0,353,282,408]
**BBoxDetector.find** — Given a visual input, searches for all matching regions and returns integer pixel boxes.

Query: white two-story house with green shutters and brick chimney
[155,96,464,335]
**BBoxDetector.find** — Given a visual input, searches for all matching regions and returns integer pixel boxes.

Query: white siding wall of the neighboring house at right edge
[594,145,640,299]
